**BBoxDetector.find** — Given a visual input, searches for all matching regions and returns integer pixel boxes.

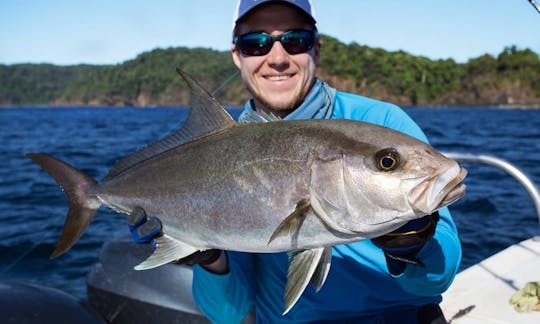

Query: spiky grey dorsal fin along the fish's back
[104,68,236,180]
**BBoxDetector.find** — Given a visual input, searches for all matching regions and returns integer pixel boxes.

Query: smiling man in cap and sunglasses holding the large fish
[130,0,461,323]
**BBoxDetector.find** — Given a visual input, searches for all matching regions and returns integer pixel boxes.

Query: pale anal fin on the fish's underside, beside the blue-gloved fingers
[135,234,200,270]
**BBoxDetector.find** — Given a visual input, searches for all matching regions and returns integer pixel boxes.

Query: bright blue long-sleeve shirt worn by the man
[193,92,461,323]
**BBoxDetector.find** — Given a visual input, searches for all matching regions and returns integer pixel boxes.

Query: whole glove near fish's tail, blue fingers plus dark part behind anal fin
[128,207,222,266]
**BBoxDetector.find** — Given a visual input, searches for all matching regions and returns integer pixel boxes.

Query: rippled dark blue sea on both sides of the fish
[0,107,540,299]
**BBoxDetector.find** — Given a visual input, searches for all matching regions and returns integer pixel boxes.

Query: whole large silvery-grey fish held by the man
[28,70,466,313]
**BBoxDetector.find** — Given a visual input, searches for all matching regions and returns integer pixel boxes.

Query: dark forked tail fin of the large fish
[26,153,101,259]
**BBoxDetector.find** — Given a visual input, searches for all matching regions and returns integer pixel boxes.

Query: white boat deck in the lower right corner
[441,236,540,324]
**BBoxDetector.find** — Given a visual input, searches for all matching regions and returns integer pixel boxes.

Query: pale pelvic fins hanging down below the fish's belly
[283,247,332,315]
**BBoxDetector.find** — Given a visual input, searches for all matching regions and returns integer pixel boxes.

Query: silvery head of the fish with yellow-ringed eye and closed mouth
[311,128,467,238]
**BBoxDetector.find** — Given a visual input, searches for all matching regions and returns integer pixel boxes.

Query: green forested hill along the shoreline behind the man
[0,35,540,107]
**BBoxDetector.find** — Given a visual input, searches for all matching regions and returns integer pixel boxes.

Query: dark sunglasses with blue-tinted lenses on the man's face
[233,29,317,56]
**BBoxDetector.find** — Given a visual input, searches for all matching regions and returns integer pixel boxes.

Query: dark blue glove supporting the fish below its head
[371,212,439,275]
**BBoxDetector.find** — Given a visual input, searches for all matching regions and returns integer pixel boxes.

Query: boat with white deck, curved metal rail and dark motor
[0,153,540,324]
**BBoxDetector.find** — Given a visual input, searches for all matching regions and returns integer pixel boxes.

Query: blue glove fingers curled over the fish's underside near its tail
[128,207,163,247]
